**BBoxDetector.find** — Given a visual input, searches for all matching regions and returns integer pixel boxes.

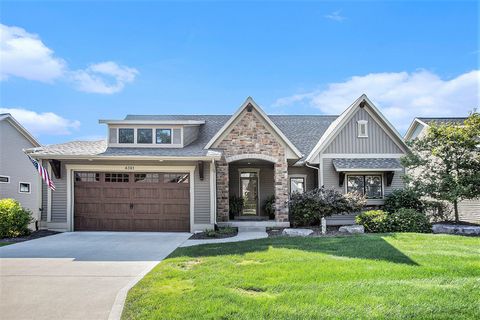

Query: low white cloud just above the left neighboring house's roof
[0,108,80,135]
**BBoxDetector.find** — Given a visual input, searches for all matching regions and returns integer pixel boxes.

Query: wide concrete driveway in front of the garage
[0,232,190,320]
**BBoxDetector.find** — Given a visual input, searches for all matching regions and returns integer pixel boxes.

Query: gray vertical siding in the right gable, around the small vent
[324,109,403,153]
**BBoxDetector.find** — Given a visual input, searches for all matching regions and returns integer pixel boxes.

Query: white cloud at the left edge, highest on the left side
[0,24,65,82]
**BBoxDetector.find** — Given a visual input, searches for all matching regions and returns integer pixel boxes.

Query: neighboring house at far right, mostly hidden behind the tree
[404,117,480,223]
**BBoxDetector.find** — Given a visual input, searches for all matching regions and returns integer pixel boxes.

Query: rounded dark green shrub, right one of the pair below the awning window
[387,208,432,233]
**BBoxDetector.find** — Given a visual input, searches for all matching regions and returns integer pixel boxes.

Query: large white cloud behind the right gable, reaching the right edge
[274,70,480,131]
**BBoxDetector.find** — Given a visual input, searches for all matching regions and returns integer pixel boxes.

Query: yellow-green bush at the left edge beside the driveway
[0,199,33,238]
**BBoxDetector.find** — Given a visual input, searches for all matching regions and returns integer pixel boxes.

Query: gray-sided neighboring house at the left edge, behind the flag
[0,113,41,226]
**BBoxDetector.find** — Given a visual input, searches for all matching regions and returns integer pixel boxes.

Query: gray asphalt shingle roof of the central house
[31,115,337,157]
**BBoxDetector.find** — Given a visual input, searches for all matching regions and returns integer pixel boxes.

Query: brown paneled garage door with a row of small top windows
[74,172,190,231]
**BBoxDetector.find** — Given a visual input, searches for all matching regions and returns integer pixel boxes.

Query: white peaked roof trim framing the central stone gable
[205,97,302,158]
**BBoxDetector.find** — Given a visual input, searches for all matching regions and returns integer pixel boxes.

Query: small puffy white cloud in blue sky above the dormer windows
[71,61,138,94]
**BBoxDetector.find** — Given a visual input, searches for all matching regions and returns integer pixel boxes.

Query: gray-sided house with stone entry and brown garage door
[25,95,407,231]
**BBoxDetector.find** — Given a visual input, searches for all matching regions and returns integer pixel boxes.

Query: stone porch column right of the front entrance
[274,160,288,222]
